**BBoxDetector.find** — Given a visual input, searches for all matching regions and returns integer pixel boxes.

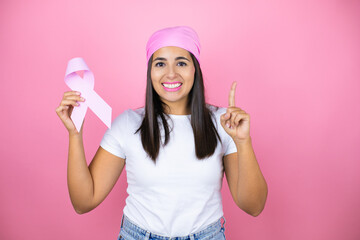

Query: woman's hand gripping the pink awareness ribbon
[56,91,85,134]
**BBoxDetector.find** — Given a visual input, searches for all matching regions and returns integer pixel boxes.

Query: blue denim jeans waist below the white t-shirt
[117,214,226,240]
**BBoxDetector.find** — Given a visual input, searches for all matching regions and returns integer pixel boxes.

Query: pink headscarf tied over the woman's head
[146,26,200,63]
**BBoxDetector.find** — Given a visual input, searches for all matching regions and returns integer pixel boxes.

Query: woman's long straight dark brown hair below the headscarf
[135,52,221,164]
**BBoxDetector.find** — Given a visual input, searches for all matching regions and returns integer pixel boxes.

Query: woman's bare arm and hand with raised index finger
[220,81,268,217]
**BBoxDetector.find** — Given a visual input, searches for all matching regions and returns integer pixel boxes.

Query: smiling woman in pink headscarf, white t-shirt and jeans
[57,26,267,240]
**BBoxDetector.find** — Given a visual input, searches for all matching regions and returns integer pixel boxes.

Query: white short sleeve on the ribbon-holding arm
[100,110,128,159]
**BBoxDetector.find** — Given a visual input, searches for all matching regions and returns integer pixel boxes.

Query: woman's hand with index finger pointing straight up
[220,81,250,143]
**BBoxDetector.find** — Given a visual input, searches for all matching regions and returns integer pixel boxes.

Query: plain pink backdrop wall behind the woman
[0,0,360,240]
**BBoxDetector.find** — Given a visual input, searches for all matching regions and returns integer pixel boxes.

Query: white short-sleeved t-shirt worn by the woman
[100,105,237,237]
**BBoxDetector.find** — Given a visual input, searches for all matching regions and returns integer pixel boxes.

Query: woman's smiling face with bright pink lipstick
[151,47,195,111]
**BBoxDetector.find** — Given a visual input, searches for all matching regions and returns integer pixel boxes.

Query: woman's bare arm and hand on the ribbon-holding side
[56,91,125,214]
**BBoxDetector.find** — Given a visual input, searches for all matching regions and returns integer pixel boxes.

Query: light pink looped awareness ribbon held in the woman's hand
[65,57,112,132]
